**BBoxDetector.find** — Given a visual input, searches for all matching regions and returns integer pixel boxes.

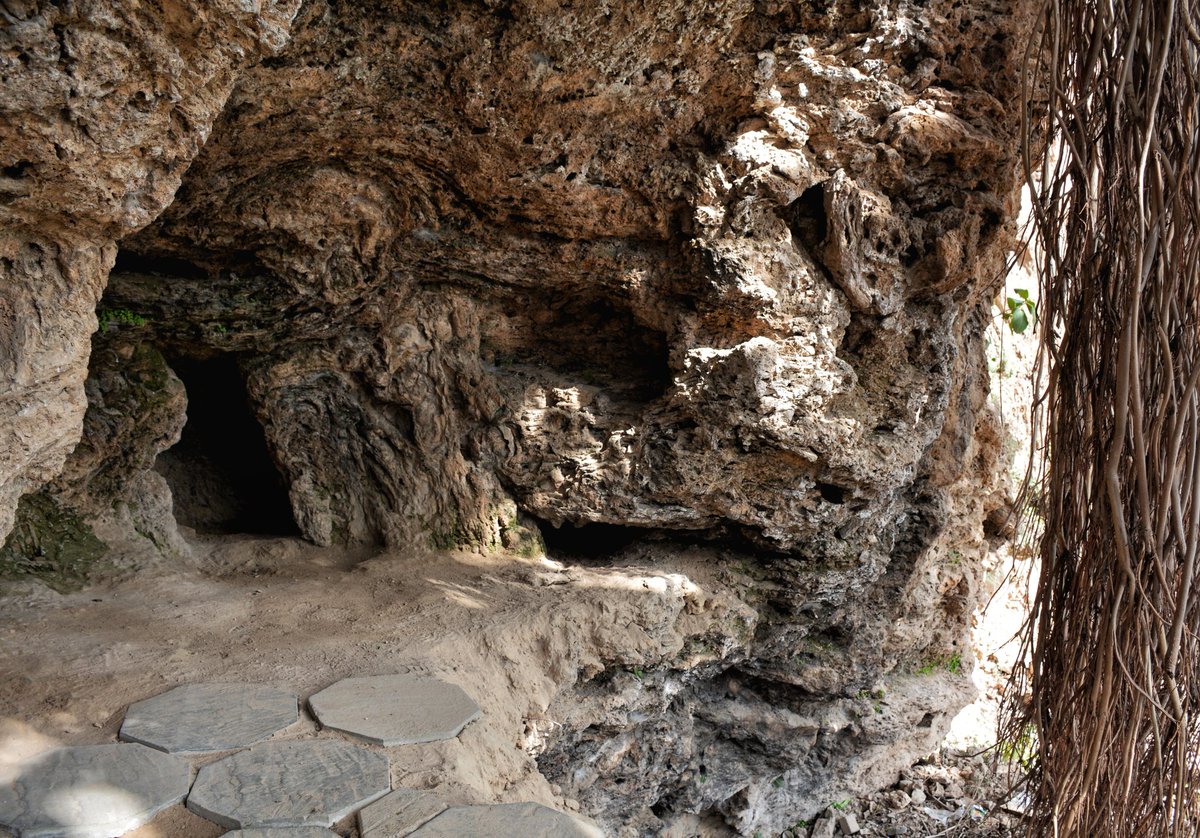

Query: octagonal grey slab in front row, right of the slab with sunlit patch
[187,740,391,830]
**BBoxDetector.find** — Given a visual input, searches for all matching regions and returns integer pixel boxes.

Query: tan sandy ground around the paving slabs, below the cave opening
[0,538,748,838]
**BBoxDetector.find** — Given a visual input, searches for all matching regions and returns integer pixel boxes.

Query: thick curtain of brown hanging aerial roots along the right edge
[1006,0,1200,838]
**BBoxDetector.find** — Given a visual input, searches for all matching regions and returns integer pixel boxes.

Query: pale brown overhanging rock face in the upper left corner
[0,0,300,538]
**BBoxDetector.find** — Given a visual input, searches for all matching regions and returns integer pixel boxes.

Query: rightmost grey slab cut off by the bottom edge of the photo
[412,803,604,838]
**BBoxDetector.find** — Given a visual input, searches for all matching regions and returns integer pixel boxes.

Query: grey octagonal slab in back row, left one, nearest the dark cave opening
[121,684,300,754]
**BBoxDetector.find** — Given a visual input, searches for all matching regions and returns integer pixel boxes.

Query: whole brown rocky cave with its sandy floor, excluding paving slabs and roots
[0,0,1041,838]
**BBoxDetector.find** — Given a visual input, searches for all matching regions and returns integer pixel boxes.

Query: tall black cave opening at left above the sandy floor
[155,355,300,535]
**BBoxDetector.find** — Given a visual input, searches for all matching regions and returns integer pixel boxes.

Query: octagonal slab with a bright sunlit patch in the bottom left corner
[0,744,192,838]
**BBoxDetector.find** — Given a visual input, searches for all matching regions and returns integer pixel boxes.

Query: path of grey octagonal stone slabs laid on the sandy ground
[0,675,604,838]
